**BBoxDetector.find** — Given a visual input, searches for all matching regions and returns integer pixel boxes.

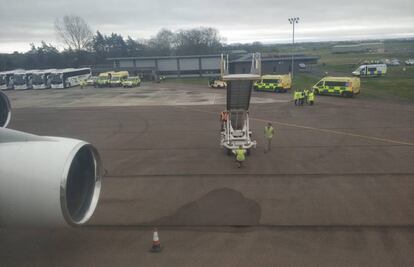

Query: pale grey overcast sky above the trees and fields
[0,0,414,53]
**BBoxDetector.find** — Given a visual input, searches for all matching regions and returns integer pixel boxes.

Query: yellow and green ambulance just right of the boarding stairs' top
[253,74,292,93]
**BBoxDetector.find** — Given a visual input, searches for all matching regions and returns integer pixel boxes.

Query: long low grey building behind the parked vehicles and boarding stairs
[104,53,319,79]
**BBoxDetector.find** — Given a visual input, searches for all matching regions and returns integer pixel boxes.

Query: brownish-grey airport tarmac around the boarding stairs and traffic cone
[0,82,414,266]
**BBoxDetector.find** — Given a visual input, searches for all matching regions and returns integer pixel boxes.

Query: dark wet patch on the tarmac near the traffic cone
[151,188,261,226]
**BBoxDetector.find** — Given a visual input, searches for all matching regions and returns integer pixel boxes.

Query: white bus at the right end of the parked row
[51,68,91,88]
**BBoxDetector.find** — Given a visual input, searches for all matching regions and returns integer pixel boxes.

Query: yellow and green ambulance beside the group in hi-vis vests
[313,77,361,97]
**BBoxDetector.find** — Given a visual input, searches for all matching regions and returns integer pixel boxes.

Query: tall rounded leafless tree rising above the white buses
[55,15,93,50]
